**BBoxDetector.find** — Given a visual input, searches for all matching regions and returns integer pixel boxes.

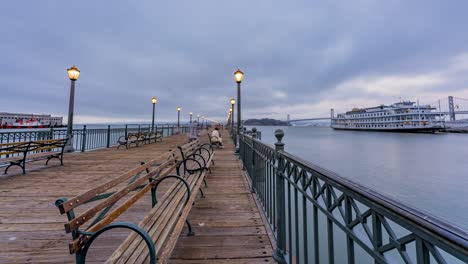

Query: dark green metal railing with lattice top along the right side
[239,129,468,264]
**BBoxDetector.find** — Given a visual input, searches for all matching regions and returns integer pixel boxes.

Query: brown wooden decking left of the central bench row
[0,135,187,263]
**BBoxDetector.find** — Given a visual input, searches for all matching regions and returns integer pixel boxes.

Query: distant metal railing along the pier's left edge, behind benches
[0,124,190,151]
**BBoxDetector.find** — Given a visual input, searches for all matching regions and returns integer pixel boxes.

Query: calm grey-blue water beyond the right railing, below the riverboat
[252,127,468,229]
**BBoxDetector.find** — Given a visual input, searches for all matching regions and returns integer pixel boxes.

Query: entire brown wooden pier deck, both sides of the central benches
[0,131,273,263]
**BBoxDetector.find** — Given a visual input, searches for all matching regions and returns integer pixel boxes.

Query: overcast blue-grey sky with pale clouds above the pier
[0,0,468,123]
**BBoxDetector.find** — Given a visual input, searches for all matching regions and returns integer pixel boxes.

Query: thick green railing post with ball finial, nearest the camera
[273,129,286,263]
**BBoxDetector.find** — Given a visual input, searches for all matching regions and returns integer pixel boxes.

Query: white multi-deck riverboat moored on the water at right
[331,101,445,133]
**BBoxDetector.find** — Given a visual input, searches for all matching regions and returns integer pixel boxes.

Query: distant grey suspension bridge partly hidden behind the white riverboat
[286,96,468,123]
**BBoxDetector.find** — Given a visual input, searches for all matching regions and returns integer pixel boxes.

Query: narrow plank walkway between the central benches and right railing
[171,131,274,263]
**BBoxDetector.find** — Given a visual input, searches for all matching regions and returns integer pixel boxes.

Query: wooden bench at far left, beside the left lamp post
[0,139,67,174]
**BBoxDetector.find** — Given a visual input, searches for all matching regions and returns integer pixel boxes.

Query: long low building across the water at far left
[0,112,63,127]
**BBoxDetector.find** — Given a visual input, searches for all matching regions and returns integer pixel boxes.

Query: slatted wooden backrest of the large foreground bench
[55,138,198,253]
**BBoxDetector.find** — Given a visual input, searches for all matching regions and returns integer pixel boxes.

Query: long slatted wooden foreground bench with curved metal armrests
[55,140,214,263]
